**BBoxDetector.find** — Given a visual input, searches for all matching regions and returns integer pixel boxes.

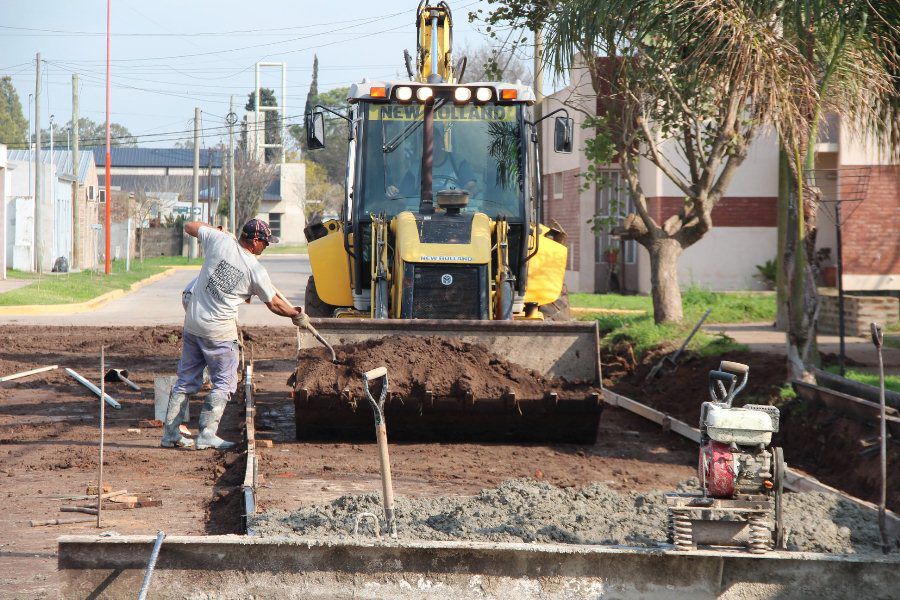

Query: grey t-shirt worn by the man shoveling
[184,227,275,341]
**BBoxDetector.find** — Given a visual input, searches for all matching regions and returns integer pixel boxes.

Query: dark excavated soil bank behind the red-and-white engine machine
[603,350,900,511]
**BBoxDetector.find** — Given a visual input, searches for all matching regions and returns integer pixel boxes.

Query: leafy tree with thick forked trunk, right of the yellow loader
[488,0,813,323]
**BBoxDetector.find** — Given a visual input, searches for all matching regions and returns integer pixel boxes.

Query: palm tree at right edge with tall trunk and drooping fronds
[778,0,900,380]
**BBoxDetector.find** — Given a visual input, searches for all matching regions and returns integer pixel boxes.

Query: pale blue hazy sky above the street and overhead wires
[0,0,554,147]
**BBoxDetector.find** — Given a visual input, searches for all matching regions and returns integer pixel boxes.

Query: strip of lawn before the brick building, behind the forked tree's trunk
[569,287,775,323]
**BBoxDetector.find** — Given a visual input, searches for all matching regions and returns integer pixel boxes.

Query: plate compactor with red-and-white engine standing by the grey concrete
[666,361,785,554]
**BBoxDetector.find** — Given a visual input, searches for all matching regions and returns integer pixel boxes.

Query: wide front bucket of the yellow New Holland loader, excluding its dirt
[294,319,603,444]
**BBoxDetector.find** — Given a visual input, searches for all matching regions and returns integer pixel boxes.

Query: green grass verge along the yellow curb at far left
[0,256,202,306]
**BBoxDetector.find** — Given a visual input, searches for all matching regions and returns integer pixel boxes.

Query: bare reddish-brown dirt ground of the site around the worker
[0,326,896,598]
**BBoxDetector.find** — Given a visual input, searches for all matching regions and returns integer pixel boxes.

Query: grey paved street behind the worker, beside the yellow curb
[0,254,311,326]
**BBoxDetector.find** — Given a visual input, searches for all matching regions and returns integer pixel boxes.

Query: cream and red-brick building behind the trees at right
[542,57,900,294]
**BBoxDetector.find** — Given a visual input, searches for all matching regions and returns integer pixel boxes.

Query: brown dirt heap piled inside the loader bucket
[294,336,590,399]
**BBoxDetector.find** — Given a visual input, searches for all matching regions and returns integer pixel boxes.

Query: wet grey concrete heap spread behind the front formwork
[250,479,880,553]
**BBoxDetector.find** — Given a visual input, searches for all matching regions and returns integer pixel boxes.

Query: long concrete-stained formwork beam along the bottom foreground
[59,536,900,600]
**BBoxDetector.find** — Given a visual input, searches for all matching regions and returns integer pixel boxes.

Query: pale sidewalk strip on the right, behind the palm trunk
[703,323,900,374]
